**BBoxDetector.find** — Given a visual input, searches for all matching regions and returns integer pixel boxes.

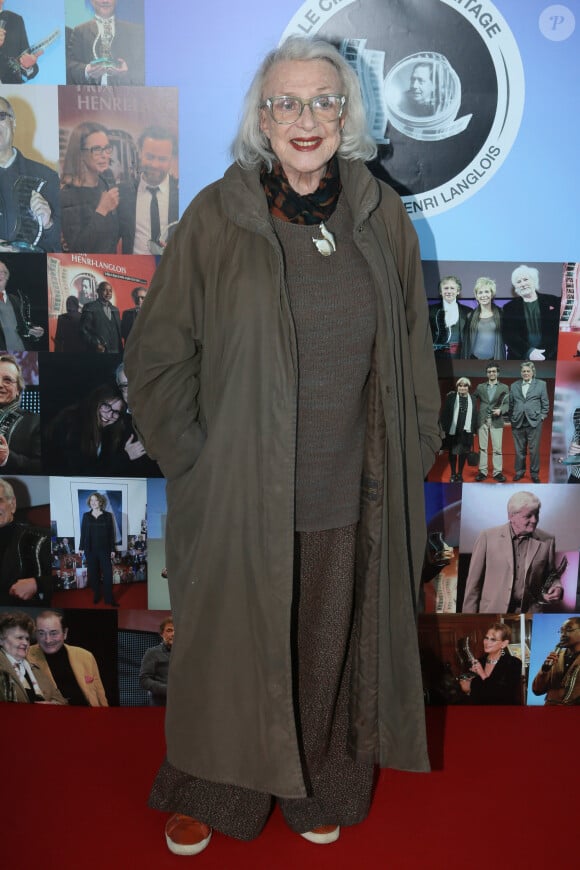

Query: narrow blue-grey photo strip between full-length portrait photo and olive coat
[147,478,170,610]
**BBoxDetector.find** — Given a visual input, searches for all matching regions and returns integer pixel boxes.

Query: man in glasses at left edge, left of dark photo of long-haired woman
[0,354,42,474]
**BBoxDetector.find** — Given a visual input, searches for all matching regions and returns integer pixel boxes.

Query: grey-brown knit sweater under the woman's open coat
[274,197,376,531]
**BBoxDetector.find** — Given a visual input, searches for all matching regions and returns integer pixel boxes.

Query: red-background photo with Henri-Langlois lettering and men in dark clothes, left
[46,254,156,354]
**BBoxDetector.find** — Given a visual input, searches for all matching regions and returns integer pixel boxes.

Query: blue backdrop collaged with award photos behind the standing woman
[0,0,580,705]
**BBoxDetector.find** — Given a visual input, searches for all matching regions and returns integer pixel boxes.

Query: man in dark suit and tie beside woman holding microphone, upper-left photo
[119,126,179,254]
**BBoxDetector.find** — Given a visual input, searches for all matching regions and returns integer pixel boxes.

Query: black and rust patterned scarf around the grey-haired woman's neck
[260,157,342,226]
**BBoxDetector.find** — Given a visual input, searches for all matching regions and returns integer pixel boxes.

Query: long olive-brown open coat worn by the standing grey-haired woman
[125,160,440,797]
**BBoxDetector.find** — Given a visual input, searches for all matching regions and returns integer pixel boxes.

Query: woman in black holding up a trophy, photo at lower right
[459,622,522,704]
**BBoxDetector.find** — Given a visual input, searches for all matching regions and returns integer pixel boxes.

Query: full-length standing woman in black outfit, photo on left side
[79,492,119,607]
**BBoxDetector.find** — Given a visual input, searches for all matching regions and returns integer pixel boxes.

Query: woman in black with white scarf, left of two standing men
[440,378,477,483]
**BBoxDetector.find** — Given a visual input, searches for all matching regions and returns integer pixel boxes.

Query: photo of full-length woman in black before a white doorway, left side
[50,477,147,609]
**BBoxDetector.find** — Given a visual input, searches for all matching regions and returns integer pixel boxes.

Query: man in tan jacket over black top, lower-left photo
[29,610,109,707]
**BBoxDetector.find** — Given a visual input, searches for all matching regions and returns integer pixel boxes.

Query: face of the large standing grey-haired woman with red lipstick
[260,60,344,194]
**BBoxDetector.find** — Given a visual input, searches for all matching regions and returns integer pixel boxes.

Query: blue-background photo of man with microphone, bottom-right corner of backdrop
[528,601,580,707]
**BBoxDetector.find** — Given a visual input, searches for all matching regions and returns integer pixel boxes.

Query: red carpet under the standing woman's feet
[0,704,580,870]
